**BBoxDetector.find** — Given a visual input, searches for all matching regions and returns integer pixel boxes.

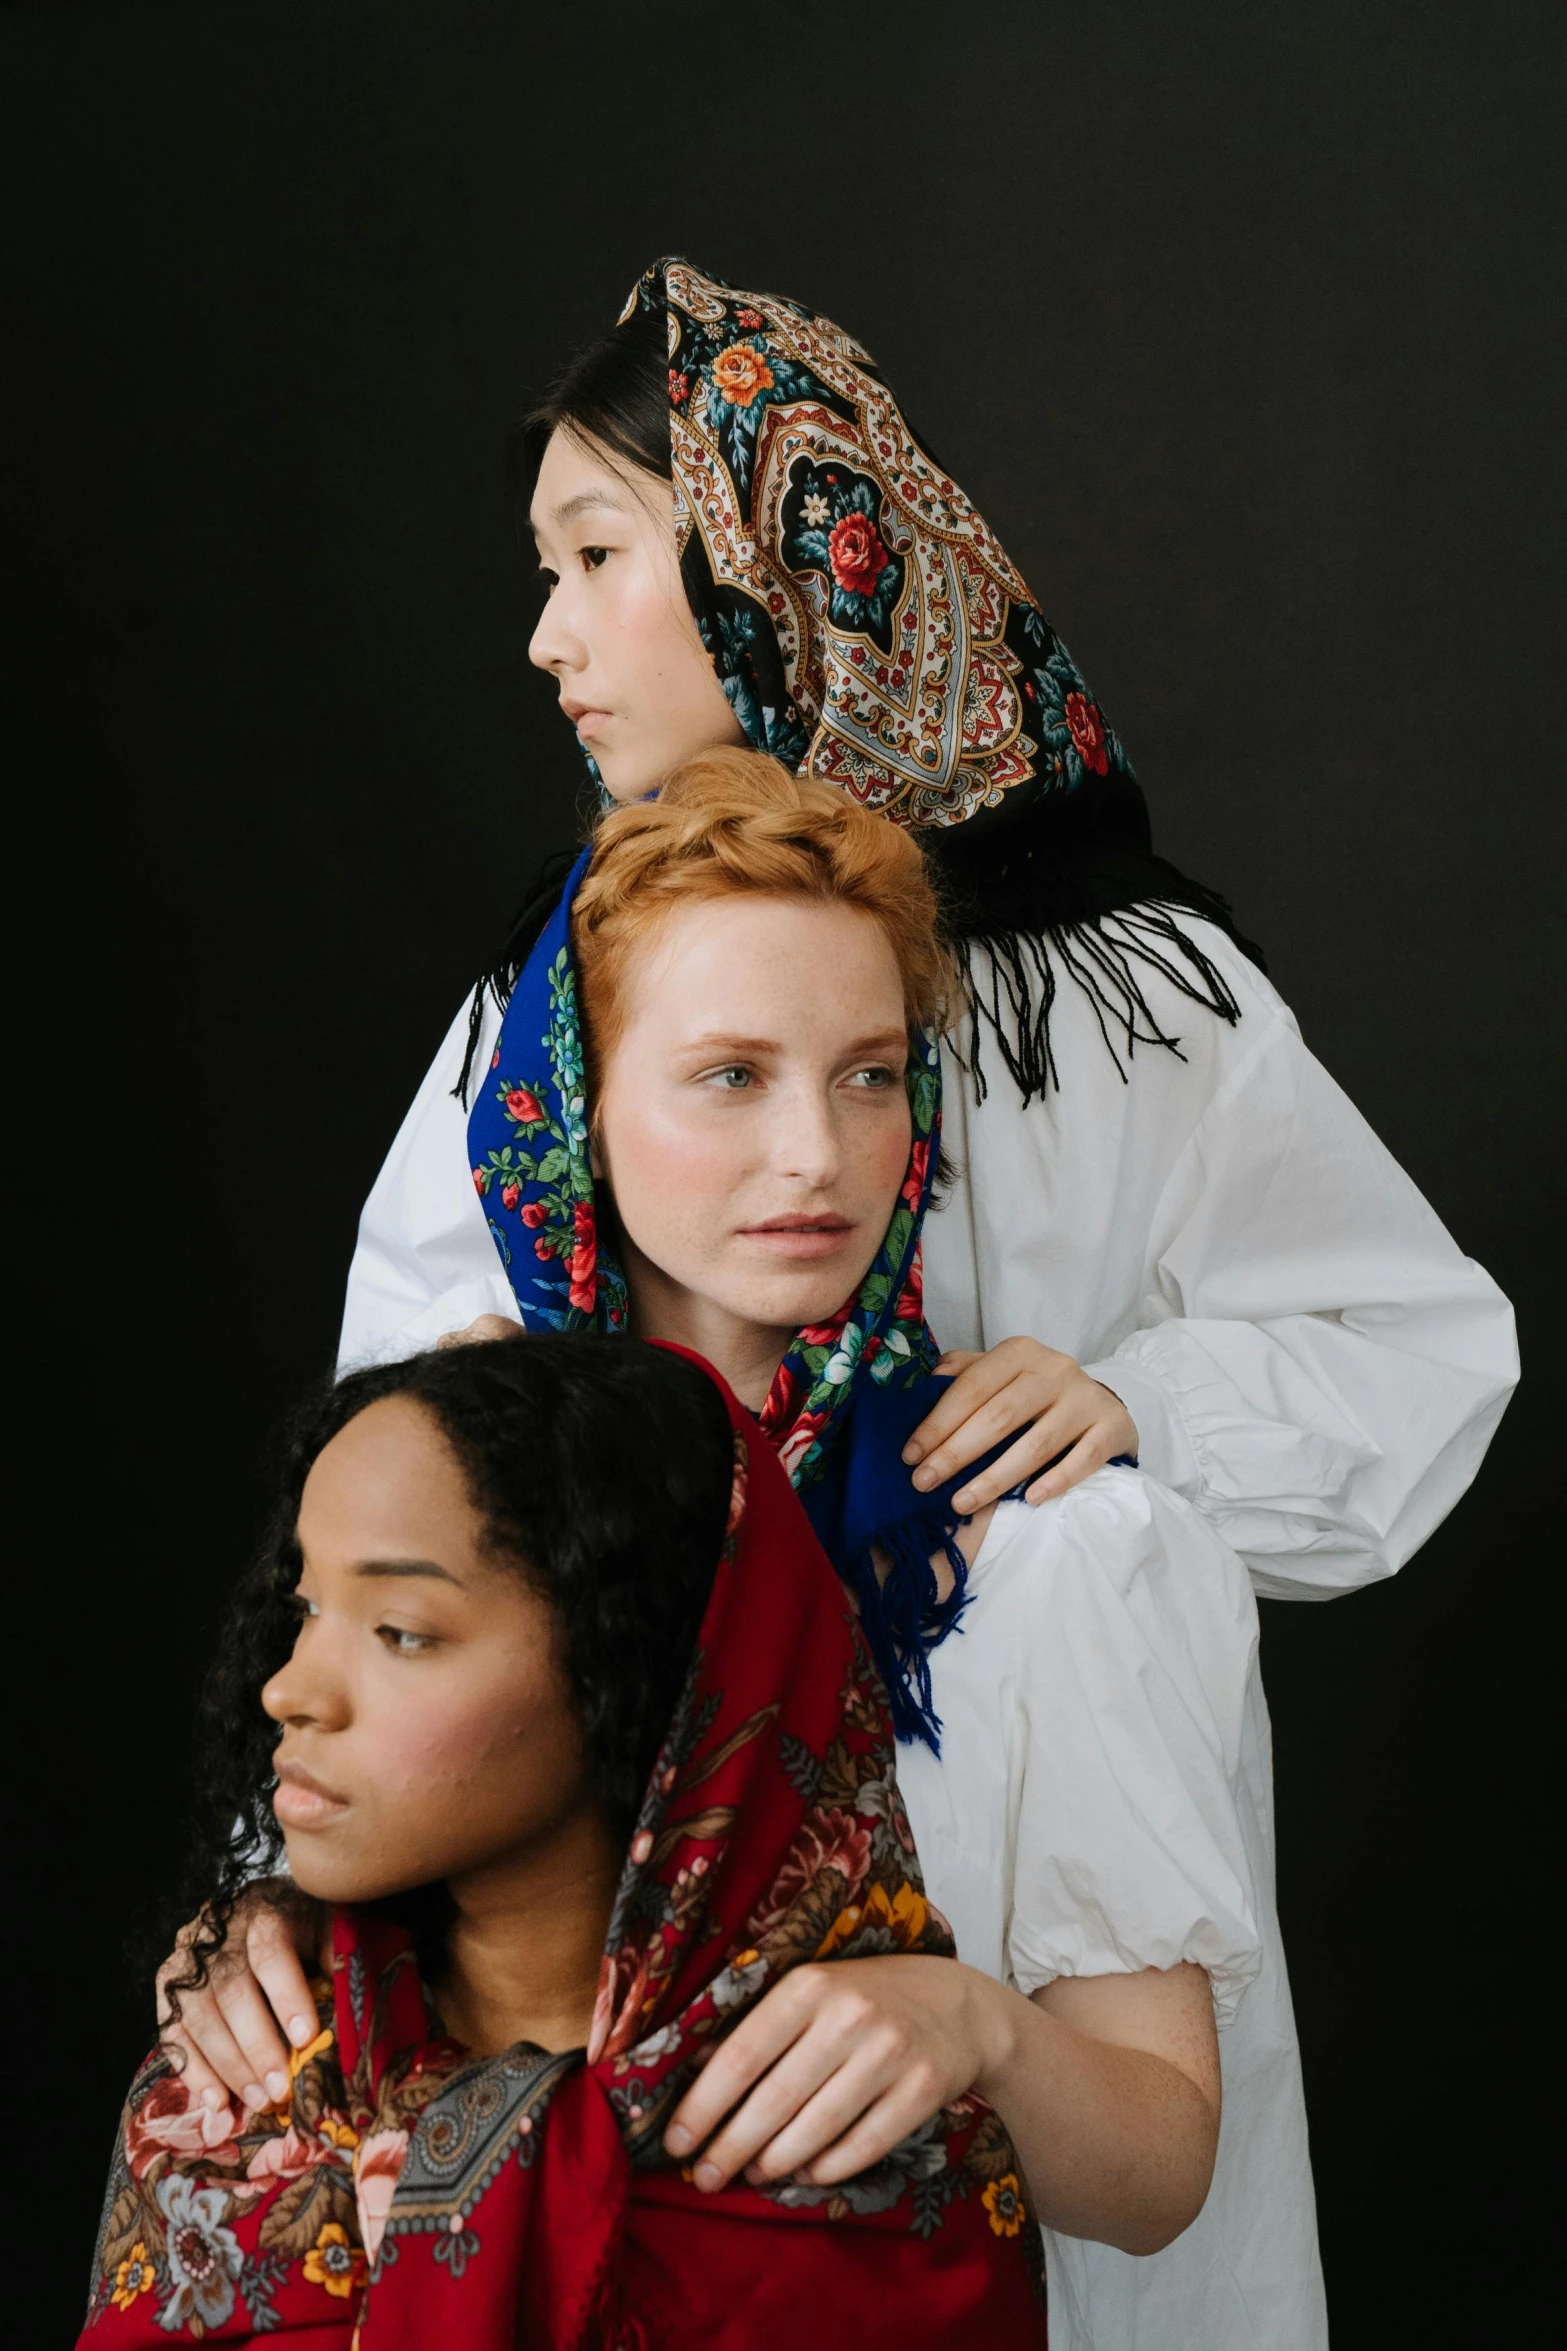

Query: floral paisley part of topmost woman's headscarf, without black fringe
[623,259,1144,828]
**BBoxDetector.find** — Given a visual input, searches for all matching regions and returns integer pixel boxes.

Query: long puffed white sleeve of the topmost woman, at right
[1088,999,1518,1599]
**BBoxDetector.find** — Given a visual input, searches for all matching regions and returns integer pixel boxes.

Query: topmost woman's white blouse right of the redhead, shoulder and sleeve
[926,919,1518,1599]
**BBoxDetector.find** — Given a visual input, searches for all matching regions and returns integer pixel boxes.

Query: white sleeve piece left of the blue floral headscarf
[338,999,517,1371]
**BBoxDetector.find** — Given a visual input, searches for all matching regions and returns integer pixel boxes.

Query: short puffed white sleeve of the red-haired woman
[1008,1469,1262,2022]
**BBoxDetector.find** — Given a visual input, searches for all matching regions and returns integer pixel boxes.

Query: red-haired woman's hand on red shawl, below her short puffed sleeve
[665,1954,1008,2189]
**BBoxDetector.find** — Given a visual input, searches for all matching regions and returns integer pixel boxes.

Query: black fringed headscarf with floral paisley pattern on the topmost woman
[623,259,1262,1098]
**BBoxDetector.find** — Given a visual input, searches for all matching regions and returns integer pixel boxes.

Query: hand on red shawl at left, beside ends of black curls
[157,1881,324,2111]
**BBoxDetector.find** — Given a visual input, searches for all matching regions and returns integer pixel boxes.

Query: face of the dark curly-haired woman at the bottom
[261,1396,587,1902]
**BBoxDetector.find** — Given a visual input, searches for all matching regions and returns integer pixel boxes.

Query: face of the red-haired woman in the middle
[594,893,909,1335]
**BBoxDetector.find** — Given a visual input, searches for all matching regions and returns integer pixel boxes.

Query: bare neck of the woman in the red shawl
[437,1810,623,2057]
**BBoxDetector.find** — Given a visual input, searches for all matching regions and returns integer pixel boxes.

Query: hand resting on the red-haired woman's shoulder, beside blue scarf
[902,1338,1137,1514]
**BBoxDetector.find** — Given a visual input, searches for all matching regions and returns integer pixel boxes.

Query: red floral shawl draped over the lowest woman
[82,1363,1043,2351]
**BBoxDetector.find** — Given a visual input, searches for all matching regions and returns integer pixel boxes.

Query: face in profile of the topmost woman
[529,433,745,799]
